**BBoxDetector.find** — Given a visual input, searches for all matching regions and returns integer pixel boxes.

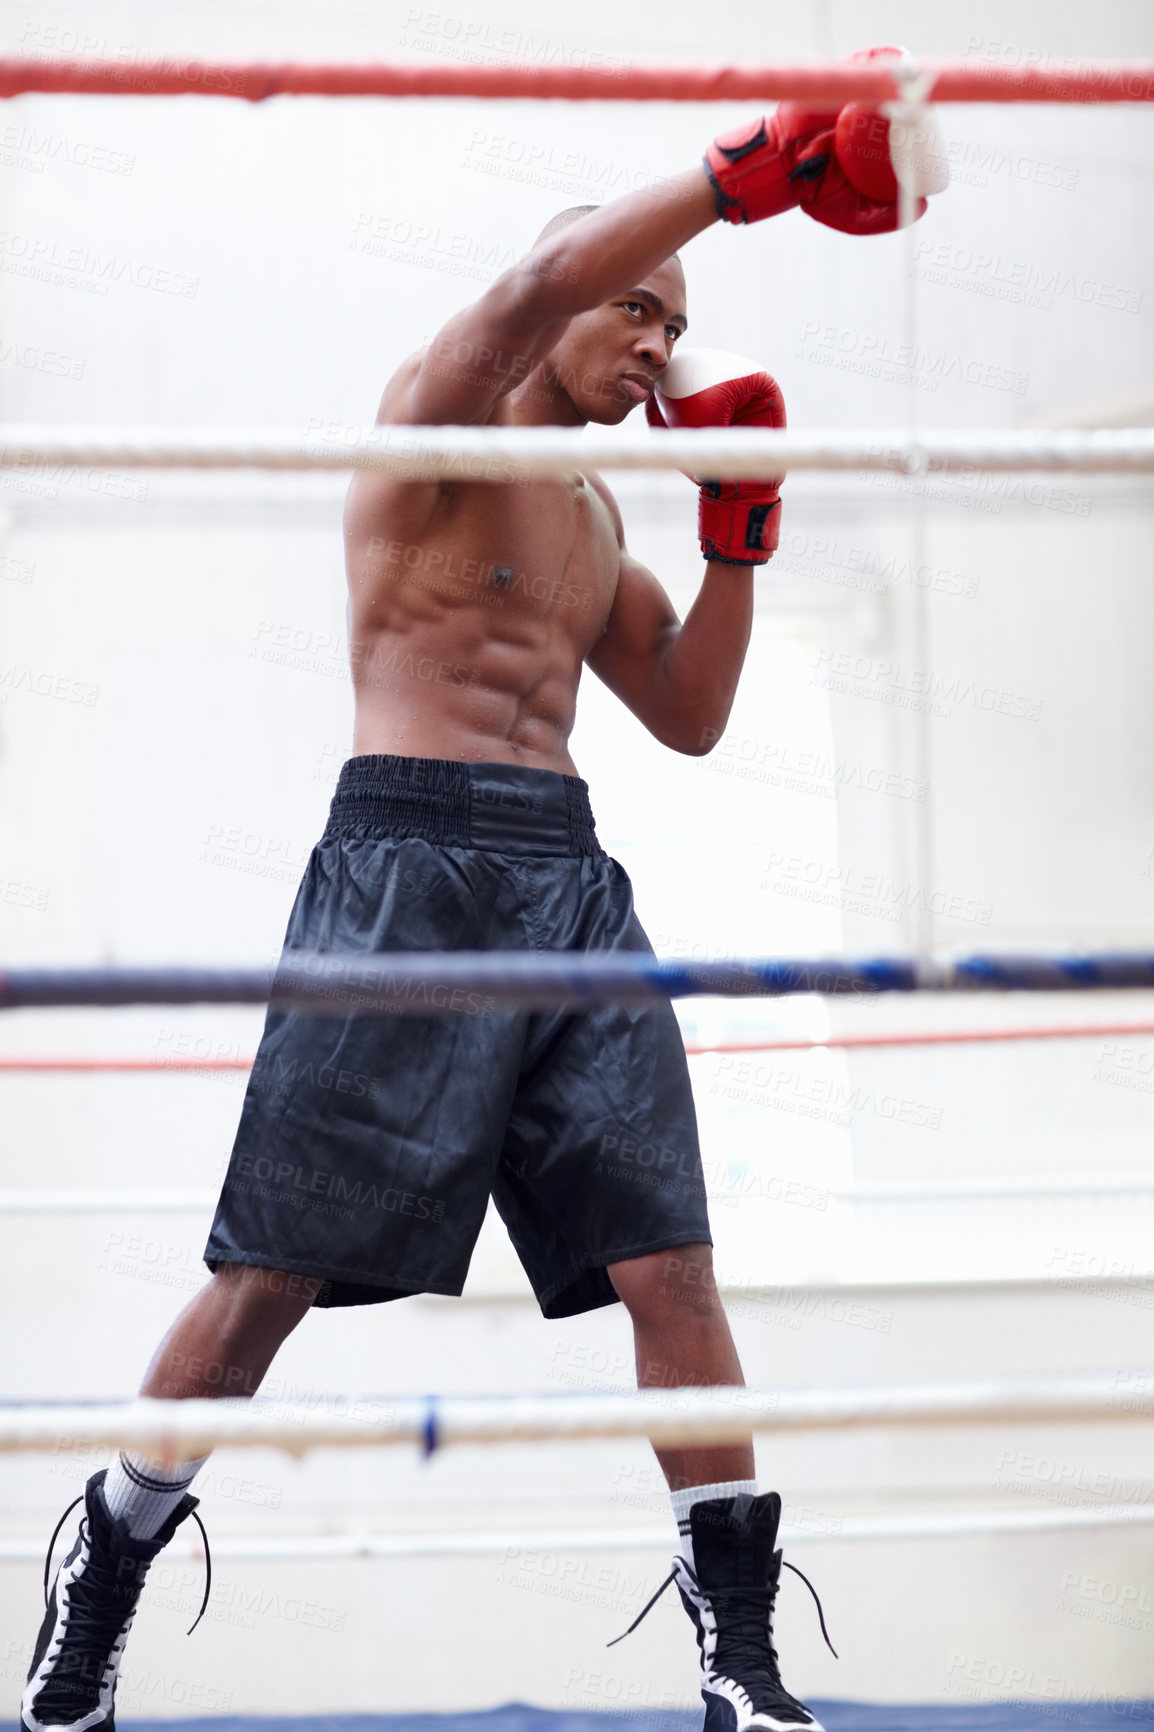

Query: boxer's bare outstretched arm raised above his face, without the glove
[400,168,717,426]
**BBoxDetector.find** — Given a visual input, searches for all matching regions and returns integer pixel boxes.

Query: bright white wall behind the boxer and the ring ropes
[0,0,1154,1715]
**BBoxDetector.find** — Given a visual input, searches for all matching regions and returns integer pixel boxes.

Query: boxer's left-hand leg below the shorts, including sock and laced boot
[21,1264,321,1732]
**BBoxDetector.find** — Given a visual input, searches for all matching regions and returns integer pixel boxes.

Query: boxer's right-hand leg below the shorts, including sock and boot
[608,1244,821,1732]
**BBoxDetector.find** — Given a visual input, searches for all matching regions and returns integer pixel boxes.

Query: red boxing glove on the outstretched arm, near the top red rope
[705,48,944,234]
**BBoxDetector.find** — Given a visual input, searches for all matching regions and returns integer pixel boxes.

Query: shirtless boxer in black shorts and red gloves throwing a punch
[23,61,942,1732]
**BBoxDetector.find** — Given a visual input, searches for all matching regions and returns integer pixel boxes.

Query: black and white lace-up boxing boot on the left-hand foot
[21,1470,211,1732]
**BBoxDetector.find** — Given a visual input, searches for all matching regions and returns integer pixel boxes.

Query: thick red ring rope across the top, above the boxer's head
[0,50,1154,104]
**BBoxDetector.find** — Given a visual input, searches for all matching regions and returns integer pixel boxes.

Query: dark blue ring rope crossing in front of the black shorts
[0,951,1154,1017]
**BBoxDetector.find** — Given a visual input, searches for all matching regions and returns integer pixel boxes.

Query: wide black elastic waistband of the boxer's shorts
[324,753,601,854]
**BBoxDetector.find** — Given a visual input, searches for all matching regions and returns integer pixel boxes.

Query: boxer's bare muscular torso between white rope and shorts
[345,372,620,776]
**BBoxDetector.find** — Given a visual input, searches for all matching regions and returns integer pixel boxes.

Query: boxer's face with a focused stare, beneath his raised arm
[544,258,686,426]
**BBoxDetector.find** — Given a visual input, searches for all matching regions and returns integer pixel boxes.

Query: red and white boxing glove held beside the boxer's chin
[645,348,785,565]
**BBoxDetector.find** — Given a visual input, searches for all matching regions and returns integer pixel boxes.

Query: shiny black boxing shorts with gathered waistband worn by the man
[204,757,710,1318]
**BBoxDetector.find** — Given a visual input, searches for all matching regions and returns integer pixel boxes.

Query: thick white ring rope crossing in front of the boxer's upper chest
[0,423,1154,481]
